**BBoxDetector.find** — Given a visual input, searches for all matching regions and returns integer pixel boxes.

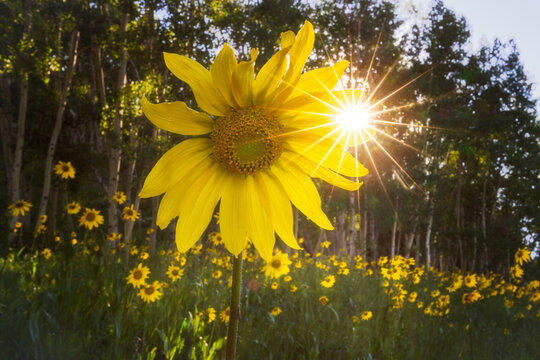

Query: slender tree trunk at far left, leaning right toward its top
[35,29,80,230]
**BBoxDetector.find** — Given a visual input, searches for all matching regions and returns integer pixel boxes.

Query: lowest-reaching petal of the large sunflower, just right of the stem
[245,176,276,261]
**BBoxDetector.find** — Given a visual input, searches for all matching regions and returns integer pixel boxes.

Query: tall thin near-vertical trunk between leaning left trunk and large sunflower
[107,13,128,233]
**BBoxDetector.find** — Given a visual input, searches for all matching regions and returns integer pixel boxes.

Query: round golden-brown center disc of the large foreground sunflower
[210,108,283,174]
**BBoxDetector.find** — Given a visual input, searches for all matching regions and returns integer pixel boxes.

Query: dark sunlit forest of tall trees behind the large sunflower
[0,0,540,278]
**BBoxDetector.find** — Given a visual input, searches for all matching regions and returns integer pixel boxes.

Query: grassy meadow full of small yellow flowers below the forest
[0,204,540,359]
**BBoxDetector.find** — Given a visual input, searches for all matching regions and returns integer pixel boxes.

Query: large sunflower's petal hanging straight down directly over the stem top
[219,174,249,256]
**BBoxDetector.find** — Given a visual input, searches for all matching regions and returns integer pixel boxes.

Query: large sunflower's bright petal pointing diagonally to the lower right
[270,158,334,230]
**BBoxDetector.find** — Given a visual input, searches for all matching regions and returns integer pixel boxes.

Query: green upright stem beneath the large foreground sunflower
[225,254,242,360]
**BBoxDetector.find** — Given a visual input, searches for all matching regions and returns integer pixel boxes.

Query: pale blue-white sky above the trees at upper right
[397,0,540,108]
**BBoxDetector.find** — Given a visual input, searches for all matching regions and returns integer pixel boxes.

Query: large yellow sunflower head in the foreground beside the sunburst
[139,22,367,261]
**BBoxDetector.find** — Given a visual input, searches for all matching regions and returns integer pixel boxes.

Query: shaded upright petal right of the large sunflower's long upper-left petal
[210,44,238,107]
